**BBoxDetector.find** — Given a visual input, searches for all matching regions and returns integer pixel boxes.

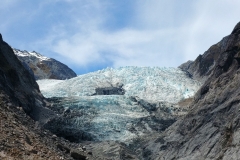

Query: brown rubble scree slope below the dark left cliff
[0,90,72,160]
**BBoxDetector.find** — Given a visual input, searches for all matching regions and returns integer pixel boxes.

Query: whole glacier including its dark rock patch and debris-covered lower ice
[38,67,201,143]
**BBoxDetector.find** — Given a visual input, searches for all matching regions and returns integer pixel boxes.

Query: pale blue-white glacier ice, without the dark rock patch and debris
[37,67,201,143]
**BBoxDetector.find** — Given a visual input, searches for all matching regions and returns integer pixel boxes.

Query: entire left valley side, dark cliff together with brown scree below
[0,34,76,160]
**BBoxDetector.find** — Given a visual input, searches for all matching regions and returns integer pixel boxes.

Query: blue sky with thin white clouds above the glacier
[0,0,240,74]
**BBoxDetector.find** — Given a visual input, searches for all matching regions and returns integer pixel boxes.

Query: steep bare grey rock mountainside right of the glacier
[143,23,240,160]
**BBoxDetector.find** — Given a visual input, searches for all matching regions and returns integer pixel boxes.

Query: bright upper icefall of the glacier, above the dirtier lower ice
[37,67,201,103]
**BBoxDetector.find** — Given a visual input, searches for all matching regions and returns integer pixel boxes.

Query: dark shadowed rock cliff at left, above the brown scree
[0,33,54,122]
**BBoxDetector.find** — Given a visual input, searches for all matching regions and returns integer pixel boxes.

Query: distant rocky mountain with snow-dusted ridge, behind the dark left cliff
[13,49,77,80]
